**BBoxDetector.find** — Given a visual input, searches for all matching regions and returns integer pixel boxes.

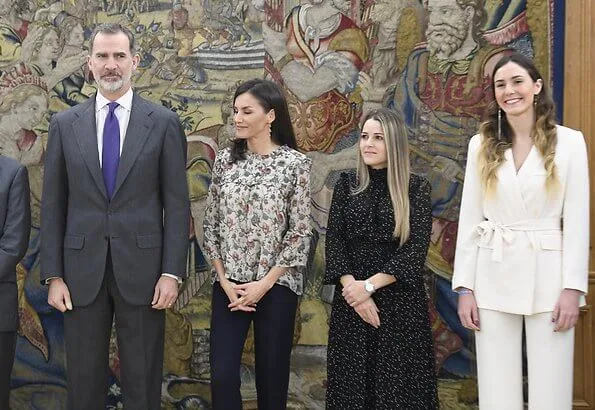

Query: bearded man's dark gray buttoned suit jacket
[41,94,190,306]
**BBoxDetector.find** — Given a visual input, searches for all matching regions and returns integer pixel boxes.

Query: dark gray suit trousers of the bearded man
[64,252,165,410]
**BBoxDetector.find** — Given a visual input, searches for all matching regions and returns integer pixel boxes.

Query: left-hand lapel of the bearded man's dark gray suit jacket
[72,97,107,198]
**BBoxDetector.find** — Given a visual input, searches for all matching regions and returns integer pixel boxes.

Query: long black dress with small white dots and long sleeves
[325,169,438,410]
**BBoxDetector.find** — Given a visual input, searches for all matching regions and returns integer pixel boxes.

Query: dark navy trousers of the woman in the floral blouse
[210,282,298,410]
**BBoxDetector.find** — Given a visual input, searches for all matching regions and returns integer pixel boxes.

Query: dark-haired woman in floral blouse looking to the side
[204,79,311,410]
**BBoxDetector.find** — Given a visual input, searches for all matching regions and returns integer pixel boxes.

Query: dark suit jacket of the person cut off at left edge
[0,155,31,332]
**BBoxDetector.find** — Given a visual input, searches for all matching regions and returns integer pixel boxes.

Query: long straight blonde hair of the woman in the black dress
[352,108,410,246]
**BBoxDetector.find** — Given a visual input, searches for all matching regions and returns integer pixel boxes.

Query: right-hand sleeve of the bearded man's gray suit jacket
[159,114,190,278]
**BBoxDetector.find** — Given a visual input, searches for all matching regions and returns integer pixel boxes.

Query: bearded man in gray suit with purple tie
[41,24,190,410]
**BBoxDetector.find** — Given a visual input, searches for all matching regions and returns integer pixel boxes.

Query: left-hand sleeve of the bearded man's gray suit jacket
[40,115,68,284]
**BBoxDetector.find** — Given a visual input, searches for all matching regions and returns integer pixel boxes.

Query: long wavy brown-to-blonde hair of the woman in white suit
[478,52,559,195]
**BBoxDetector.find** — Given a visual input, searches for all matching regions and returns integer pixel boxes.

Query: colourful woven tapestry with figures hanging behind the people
[0,0,563,410]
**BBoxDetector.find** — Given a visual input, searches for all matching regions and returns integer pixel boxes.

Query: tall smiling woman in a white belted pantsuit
[453,53,589,410]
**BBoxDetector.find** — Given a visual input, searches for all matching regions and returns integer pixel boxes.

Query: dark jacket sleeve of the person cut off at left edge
[0,166,31,282]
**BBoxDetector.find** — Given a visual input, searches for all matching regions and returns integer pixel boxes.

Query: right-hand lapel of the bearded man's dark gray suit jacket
[113,93,153,197]
